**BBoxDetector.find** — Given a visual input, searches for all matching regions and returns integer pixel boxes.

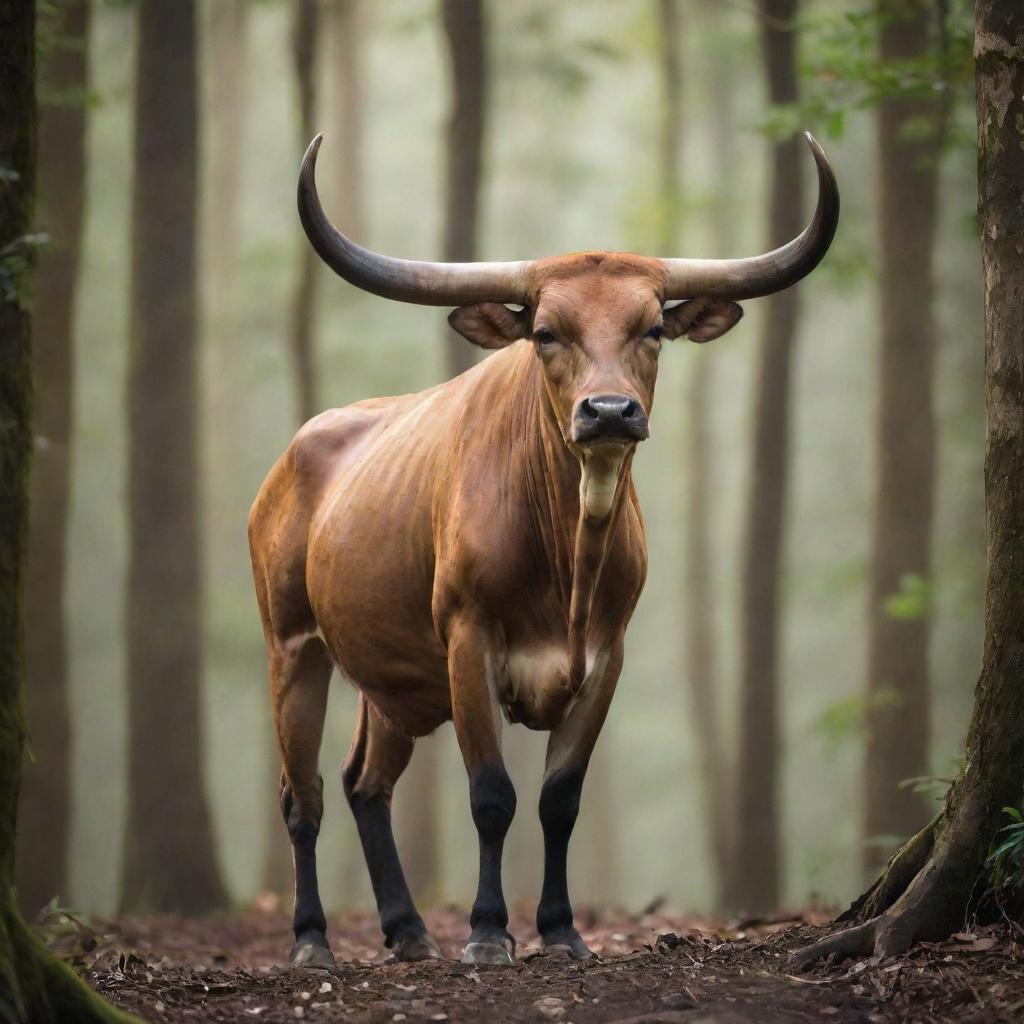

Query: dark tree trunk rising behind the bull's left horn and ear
[441,0,488,377]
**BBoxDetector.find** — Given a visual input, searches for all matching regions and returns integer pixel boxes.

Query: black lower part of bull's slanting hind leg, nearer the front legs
[347,792,427,949]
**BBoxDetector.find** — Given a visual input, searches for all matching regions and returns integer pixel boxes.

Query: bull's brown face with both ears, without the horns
[450,253,742,449]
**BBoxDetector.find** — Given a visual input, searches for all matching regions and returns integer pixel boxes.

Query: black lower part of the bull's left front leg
[469,763,516,950]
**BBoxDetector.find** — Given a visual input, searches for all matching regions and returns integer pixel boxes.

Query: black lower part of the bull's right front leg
[537,768,589,956]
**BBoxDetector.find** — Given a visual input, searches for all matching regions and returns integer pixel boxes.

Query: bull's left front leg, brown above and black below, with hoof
[449,620,516,964]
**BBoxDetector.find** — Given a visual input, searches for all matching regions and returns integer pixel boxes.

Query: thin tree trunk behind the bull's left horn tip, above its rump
[291,0,318,423]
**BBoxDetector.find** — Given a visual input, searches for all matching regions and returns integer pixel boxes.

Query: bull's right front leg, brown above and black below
[537,641,623,959]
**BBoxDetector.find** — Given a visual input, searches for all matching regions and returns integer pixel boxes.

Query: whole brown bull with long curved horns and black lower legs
[249,136,839,966]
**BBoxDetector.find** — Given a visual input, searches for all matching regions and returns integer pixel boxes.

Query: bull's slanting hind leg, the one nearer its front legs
[341,694,441,961]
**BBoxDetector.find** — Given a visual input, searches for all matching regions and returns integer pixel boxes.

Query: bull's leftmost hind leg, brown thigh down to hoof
[269,635,334,967]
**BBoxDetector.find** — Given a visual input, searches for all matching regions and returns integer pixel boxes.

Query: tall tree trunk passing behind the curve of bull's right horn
[730,0,803,912]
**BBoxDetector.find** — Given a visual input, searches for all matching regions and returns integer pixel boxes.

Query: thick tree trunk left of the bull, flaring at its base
[122,0,227,912]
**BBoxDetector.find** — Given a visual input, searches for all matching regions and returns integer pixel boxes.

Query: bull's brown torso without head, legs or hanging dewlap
[254,343,646,737]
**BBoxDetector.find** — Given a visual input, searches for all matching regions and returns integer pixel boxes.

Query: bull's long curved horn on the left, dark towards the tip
[298,133,530,306]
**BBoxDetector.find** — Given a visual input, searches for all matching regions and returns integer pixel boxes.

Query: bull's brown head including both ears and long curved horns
[298,134,839,451]
